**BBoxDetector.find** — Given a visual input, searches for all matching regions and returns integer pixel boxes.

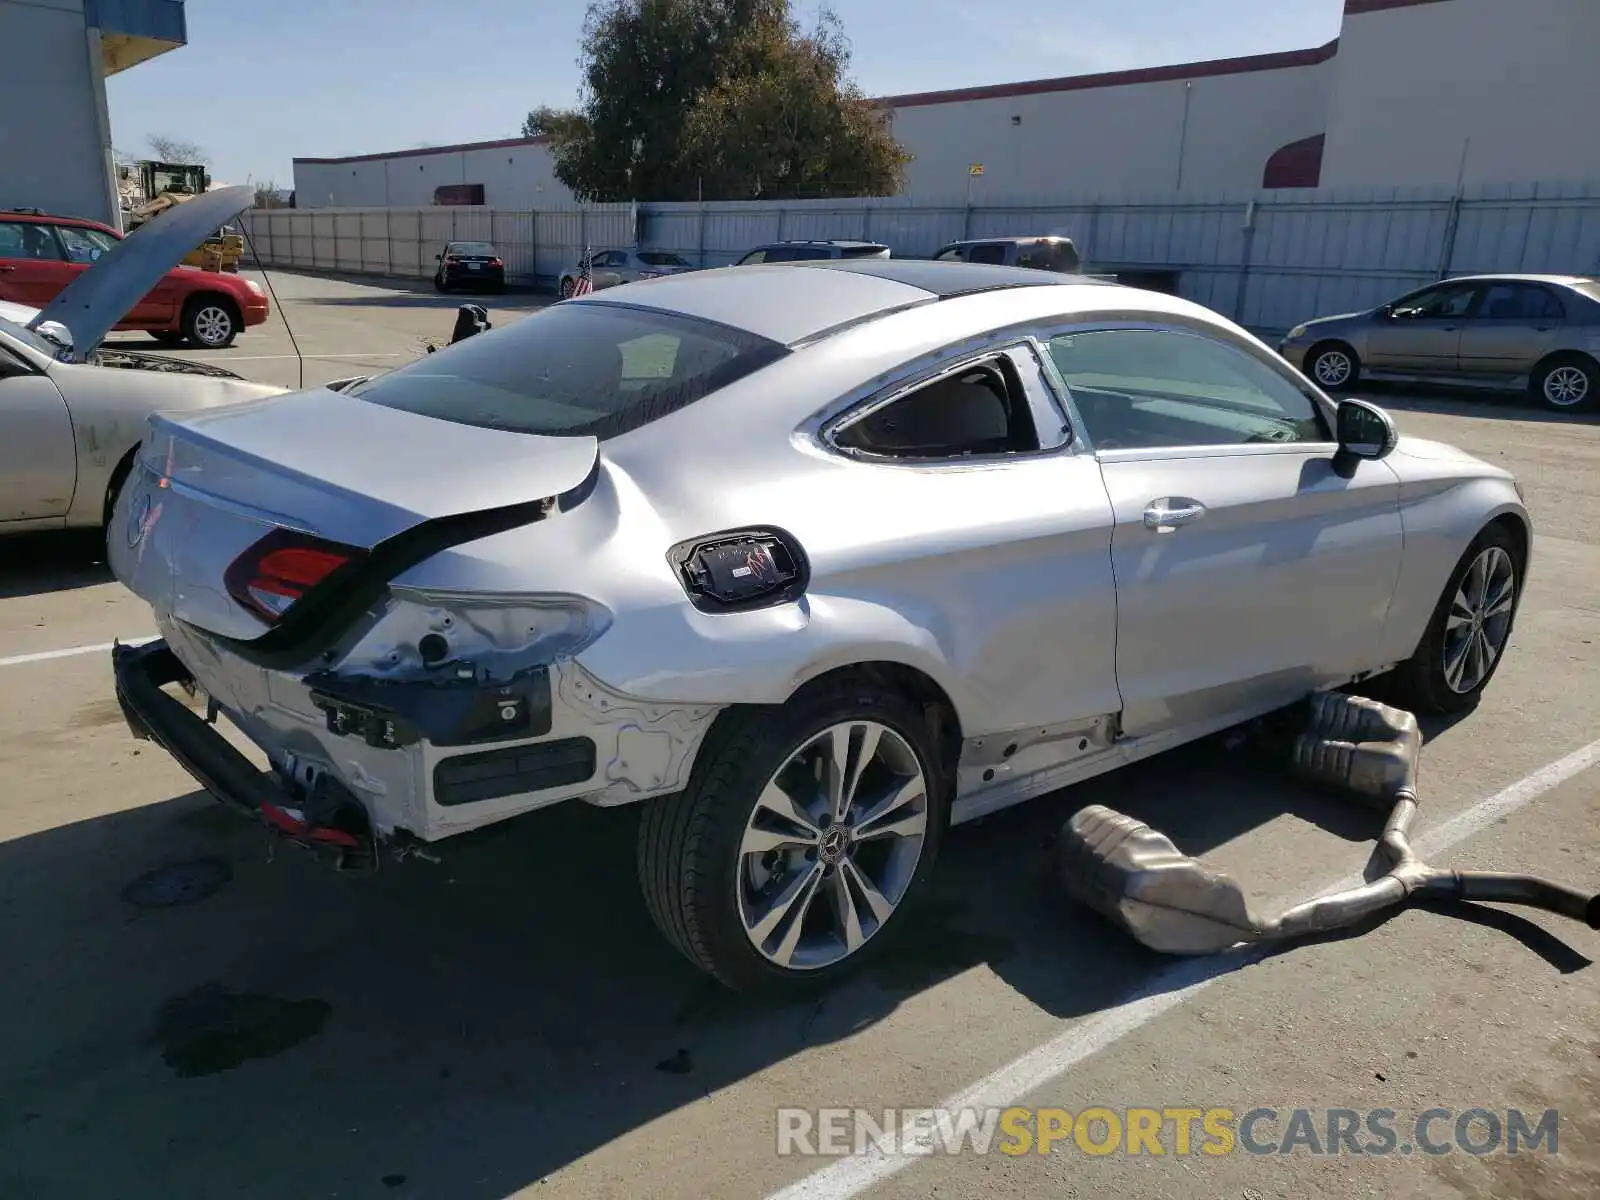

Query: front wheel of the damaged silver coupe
[1395,522,1523,714]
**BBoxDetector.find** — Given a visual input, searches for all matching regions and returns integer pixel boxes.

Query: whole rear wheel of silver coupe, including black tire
[637,678,949,992]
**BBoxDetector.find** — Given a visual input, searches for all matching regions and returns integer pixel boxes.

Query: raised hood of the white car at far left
[27,186,253,363]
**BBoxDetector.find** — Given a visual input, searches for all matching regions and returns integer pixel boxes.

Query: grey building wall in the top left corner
[0,0,117,226]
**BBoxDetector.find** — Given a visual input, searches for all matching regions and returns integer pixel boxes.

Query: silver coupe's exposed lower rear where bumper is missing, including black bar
[112,619,717,866]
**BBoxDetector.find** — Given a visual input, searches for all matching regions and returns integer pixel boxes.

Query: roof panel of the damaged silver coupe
[563,259,1118,346]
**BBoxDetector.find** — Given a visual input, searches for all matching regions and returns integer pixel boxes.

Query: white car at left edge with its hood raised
[0,187,285,536]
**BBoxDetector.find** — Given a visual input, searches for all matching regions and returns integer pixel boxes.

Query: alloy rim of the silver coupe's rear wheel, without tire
[734,720,930,971]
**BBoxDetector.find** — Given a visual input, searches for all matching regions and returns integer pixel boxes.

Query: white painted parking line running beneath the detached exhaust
[768,739,1600,1200]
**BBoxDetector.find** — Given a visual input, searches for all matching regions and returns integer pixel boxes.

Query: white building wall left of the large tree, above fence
[294,142,576,210]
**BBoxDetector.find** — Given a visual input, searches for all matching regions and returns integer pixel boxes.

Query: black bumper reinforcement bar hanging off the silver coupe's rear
[110,640,378,869]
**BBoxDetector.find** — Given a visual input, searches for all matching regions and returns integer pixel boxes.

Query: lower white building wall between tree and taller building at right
[894,51,1333,203]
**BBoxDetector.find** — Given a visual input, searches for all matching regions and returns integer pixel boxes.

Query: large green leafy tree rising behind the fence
[523,0,909,200]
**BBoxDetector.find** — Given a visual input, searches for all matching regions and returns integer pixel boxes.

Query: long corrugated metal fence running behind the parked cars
[236,182,1600,330]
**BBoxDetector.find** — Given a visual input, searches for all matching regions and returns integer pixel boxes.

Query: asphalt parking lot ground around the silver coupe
[9,274,1600,1200]
